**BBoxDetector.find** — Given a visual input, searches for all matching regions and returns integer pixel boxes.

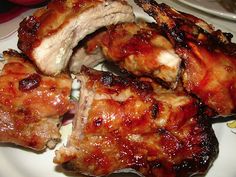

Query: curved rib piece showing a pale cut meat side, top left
[18,0,134,75]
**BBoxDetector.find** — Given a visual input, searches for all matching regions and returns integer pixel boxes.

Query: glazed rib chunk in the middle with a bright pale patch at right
[71,22,181,88]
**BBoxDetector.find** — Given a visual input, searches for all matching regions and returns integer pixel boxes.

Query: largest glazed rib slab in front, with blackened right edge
[54,67,218,177]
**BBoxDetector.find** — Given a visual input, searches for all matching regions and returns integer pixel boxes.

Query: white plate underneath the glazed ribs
[0,0,236,177]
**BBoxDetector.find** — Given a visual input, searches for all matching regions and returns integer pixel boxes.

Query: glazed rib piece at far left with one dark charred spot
[0,50,71,151]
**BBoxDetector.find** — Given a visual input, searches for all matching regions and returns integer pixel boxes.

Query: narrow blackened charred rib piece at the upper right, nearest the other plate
[134,0,229,43]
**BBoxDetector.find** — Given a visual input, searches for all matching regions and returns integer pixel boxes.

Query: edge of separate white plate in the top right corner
[178,0,236,20]
